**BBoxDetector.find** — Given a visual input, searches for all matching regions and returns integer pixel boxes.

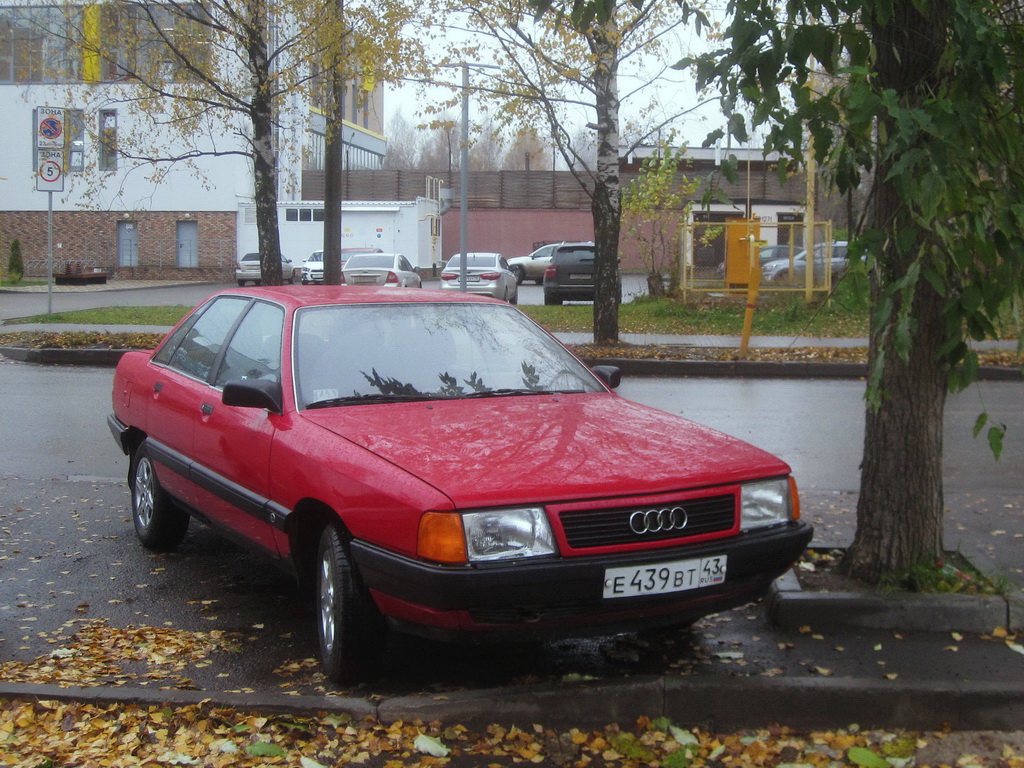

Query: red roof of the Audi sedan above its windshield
[210,286,508,310]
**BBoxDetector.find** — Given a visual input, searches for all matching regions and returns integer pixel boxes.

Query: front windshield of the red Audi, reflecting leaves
[294,302,603,408]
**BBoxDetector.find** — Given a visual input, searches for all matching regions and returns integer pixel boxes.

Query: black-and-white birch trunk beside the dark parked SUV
[591,22,622,344]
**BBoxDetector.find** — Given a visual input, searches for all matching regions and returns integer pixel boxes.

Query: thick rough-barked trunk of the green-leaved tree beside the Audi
[844,0,949,582]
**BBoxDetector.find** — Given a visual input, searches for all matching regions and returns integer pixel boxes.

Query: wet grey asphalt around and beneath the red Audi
[0,362,1024,695]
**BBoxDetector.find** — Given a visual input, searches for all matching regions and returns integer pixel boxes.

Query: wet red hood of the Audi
[303,393,790,508]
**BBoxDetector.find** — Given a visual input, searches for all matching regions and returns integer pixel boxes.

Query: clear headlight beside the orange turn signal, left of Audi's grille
[462,507,555,562]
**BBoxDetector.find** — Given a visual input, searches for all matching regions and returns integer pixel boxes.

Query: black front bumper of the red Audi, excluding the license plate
[351,521,813,638]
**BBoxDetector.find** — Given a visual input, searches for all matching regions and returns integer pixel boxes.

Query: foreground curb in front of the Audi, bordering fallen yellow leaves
[6,675,1024,731]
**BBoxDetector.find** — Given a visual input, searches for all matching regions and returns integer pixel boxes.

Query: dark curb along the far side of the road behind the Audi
[0,347,1024,381]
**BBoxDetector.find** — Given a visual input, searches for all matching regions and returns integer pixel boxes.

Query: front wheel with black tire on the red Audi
[316,525,387,683]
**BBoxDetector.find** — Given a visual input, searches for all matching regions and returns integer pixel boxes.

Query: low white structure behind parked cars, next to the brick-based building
[238,198,442,269]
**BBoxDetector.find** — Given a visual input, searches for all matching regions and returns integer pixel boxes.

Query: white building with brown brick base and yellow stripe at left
[0,2,386,279]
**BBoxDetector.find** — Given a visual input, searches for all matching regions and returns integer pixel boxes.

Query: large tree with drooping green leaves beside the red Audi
[696,0,1024,582]
